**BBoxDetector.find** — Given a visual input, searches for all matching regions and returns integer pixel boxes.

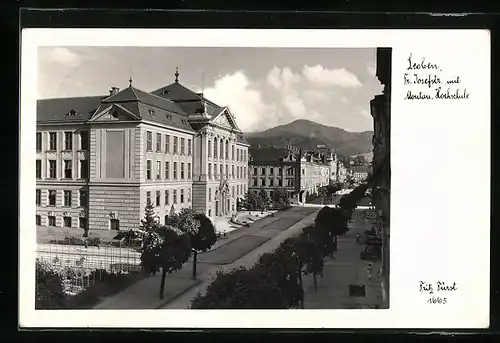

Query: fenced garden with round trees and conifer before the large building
[36,204,218,309]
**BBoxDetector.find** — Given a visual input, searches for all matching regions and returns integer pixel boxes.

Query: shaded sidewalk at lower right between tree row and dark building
[304,211,382,309]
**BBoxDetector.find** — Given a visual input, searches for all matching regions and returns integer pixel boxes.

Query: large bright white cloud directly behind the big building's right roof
[204,70,275,131]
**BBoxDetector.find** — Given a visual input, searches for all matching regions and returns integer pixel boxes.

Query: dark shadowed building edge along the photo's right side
[371,48,391,304]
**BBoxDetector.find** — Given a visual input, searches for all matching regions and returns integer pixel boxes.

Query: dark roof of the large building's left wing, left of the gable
[36,96,106,122]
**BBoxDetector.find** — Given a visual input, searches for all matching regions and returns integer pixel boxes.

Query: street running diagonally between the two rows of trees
[94,209,317,309]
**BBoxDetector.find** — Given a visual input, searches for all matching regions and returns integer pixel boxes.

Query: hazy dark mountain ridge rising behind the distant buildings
[245,119,373,156]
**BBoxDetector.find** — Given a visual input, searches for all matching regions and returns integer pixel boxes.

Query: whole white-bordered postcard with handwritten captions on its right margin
[19,29,490,328]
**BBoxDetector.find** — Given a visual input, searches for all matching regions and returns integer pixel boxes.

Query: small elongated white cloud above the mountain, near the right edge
[302,64,363,88]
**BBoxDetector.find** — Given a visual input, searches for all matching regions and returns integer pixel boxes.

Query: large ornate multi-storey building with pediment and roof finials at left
[36,72,248,235]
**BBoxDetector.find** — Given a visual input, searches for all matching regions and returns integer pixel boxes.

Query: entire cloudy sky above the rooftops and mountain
[38,47,382,132]
